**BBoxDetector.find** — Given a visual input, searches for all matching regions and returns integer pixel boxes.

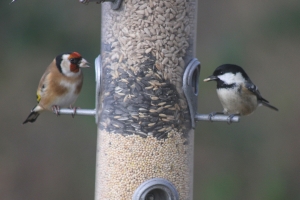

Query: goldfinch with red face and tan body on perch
[23,52,89,124]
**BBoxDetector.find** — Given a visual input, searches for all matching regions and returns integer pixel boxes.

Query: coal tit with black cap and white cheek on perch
[204,64,278,122]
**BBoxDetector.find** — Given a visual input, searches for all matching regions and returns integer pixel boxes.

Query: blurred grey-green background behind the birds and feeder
[0,0,300,200]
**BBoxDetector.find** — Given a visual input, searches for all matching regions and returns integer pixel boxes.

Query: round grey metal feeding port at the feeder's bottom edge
[132,178,179,200]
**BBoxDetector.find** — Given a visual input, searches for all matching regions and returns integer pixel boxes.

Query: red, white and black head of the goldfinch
[56,52,89,77]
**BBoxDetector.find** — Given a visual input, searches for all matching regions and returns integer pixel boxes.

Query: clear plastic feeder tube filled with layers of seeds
[95,0,197,200]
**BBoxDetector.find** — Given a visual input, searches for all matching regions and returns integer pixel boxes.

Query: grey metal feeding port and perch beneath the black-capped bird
[182,58,239,128]
